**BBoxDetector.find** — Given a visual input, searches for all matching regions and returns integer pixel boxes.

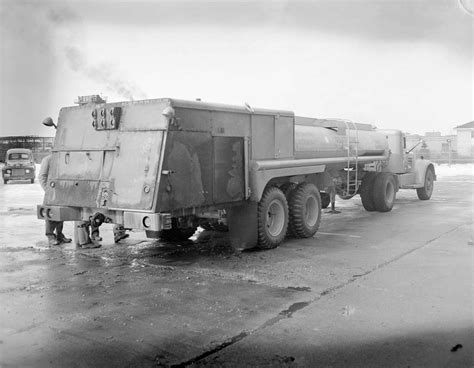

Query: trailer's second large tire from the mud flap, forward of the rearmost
[289,183,321,238]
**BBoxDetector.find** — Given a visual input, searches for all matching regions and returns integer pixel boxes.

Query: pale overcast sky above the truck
[0,0,474,136]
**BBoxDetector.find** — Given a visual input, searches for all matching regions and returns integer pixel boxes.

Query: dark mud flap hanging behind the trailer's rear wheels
[227,202,258,250]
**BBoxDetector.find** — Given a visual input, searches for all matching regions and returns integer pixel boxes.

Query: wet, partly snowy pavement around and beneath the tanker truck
[0,165,474,367]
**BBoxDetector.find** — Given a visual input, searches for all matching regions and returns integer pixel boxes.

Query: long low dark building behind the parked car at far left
[0,135,54,162]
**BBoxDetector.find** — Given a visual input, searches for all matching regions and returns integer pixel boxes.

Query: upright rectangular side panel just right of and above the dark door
[251,115,275,160]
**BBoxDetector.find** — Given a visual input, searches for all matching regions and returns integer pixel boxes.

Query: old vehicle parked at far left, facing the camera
[2,148,36,184]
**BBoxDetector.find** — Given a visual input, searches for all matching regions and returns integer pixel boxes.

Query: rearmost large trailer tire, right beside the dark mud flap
[257,187,288,249]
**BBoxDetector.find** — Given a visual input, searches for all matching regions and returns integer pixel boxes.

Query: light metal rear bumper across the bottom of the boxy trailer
[36,204,171,231]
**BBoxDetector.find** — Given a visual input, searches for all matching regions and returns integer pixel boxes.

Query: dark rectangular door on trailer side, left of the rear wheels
[213,137,245,203]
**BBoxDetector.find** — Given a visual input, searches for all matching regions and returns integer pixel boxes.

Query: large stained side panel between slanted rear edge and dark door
[157,131,213,212]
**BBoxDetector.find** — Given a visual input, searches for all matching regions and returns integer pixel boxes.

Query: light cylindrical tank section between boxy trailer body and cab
[295,124,388,158]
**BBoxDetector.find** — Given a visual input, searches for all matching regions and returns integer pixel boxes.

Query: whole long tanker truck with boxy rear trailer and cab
[37,98,436,249]
